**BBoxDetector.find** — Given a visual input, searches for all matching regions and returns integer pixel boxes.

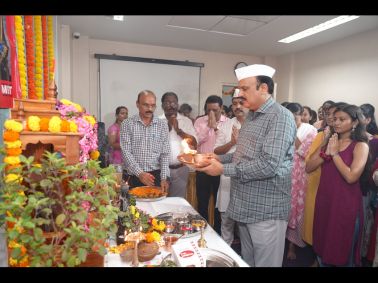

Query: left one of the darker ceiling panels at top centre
[168,16,225,30]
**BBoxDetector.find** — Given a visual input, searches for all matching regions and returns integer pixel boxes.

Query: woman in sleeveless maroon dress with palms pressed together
[307,105,369,266]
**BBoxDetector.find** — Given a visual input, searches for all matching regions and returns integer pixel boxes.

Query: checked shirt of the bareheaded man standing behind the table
[120,114,170,180]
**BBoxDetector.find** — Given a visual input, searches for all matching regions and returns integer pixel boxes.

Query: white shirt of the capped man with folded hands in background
[214,117,241,212]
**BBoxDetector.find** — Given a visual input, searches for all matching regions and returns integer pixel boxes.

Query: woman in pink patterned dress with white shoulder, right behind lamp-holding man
[286,103,318,260]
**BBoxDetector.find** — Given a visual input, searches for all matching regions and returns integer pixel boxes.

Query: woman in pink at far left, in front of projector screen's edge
[108,106,129,165]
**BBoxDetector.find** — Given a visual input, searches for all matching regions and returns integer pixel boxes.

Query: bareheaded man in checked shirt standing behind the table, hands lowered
[120,90,170,192]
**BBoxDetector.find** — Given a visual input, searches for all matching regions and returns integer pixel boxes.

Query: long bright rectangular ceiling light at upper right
[278,16,360,43]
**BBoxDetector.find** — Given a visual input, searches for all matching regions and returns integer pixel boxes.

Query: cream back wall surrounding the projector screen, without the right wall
[60,35,266,121]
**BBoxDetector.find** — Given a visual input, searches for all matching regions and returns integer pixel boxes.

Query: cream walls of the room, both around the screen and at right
[58,24,378,121]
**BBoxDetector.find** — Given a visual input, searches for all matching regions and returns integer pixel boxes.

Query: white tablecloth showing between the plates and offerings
[105,197,249,267]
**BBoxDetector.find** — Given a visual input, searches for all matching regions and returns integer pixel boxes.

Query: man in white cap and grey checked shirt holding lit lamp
[197,64,296,267]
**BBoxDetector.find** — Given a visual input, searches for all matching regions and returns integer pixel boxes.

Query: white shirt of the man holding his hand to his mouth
[159,113,197,165]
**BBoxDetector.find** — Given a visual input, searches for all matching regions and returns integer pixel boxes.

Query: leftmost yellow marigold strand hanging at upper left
[15,16,28,99]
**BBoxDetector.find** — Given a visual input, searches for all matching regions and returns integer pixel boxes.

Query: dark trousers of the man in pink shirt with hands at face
[196,171,221,235]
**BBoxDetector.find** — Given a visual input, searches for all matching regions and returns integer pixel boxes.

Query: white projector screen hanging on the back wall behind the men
[95,54,203,129]
